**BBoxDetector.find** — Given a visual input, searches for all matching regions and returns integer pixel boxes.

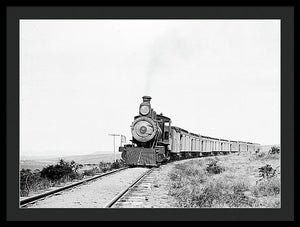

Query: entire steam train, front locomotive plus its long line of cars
[119,96,260,166]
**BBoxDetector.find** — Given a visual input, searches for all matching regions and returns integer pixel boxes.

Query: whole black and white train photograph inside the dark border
[19,19,281,209]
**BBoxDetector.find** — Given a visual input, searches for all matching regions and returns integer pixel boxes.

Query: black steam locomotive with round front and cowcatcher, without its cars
[119,96,171,166]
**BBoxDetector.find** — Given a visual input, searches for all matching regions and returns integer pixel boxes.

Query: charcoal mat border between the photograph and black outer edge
[5,6,294,221]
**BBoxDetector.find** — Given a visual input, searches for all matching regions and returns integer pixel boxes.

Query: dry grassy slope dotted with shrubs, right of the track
[169,145,280,208]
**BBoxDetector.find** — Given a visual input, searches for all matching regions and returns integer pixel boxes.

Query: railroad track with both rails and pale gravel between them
[20,160,183,208]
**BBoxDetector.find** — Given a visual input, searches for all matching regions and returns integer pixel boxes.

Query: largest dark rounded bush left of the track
[41,159,80,181]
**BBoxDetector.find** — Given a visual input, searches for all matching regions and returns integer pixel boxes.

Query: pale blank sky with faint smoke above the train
[20,20,280,156]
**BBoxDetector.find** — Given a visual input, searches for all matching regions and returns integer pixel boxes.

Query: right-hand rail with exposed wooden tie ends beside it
[104,167,158,208]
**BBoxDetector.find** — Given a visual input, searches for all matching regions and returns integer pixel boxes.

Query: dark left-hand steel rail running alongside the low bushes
[20,167,129,206]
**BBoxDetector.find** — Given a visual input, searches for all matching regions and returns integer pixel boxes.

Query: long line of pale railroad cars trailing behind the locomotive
[169,126,260,158]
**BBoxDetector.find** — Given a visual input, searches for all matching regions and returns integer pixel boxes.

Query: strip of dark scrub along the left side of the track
[20,159,125,197]
